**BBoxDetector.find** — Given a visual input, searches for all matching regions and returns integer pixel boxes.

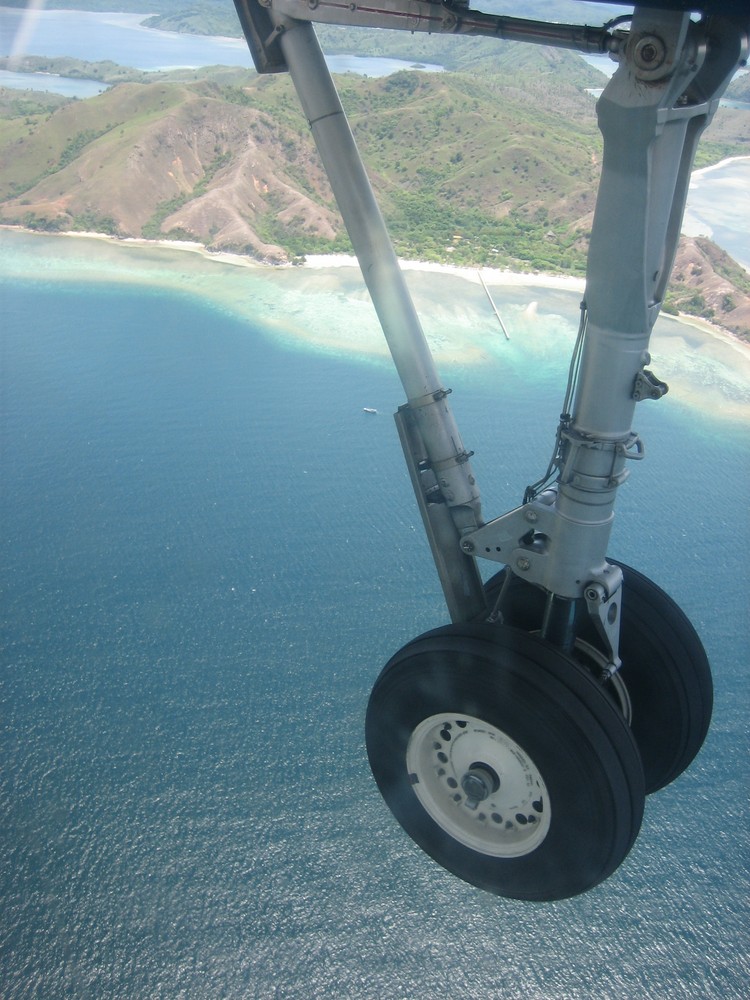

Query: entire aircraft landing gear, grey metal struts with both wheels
[236,0,750,900]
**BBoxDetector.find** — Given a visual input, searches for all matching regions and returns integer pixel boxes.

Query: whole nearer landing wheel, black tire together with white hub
[365,624,645,901]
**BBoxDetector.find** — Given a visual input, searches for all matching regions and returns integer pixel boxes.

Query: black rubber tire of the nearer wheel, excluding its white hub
[365,624,645,901]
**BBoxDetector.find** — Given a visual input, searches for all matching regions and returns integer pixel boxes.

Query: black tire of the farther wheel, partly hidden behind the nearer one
[486,559,713,794]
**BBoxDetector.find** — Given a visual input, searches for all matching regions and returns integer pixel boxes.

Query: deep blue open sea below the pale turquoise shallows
[0,270,750,1000]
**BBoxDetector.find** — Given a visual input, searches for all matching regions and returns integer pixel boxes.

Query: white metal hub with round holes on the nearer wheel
[406,714,551,858]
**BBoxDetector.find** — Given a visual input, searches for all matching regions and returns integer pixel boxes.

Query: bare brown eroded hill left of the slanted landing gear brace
[0,84,340,259]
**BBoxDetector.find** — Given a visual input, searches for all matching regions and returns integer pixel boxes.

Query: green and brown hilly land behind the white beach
[0,55,750,329]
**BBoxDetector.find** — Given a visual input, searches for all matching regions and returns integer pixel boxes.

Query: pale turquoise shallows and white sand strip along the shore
[0,225,750,423]
